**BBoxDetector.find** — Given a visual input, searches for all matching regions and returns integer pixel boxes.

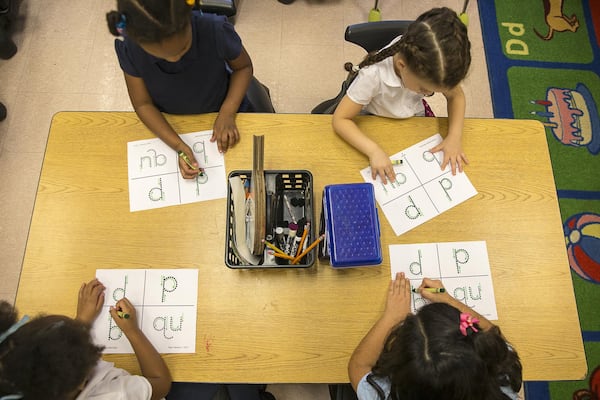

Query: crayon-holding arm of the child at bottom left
[110,298,172,400]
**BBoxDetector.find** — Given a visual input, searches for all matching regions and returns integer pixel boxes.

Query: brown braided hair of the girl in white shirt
[344,7,471,88]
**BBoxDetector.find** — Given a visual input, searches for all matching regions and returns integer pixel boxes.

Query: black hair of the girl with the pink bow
[367,303,522,400]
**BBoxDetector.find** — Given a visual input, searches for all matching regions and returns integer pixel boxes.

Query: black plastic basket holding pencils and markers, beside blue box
[225,170,318,269]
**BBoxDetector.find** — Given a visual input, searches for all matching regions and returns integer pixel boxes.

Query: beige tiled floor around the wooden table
[0,0,492,400]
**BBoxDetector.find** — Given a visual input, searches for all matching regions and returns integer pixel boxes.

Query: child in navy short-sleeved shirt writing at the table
[106,0,253,178]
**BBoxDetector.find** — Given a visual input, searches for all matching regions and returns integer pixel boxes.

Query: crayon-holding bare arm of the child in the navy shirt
[123,72,200,179]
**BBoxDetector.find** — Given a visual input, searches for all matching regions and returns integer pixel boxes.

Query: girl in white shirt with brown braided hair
[333,7,471,184]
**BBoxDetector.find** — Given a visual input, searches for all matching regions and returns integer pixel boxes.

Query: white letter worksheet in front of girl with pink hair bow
[390,241,498,320]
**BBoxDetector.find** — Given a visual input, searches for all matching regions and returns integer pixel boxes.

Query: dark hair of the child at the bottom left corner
[0,301,103,400]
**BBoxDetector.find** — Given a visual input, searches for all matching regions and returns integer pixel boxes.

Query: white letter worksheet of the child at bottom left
[92,269,198,354]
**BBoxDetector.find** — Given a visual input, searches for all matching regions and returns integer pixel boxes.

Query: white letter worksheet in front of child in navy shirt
[127,130,227,211]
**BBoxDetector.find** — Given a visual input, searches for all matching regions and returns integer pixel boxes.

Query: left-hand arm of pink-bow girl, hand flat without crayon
[348,272,411,391]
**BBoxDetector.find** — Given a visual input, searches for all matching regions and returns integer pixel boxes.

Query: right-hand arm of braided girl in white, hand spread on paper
[430,85,469,175]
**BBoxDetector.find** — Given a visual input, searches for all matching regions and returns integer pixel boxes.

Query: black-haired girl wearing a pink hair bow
[348,273,522,400]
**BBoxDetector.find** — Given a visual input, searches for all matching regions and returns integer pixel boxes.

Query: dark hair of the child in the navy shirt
[106,0,192,43]
